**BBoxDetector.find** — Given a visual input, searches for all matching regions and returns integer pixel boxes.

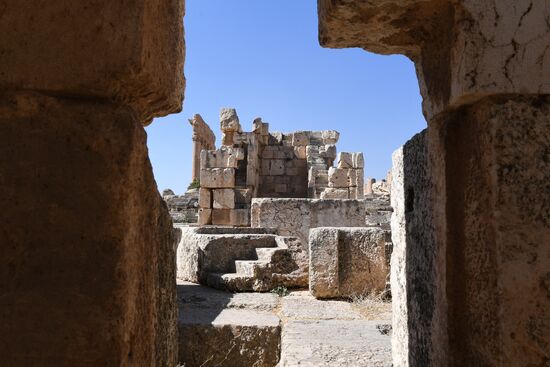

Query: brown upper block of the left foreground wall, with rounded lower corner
[0,0,185,123]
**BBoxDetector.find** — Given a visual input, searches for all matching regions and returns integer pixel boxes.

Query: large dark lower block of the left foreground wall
[0,93,177,366]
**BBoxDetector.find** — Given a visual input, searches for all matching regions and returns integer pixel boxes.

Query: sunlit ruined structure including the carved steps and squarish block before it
[177,108,391,298]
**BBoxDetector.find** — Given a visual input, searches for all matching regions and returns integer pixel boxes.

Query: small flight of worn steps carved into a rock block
[207,236,307,292]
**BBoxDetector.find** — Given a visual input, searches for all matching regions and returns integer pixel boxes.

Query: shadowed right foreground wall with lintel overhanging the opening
[319,0,550,366]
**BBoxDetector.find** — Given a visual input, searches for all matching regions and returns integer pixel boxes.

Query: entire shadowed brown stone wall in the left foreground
[0,0,184,366]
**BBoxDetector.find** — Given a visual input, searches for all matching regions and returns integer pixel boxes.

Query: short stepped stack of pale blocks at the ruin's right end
[321,152,365,200]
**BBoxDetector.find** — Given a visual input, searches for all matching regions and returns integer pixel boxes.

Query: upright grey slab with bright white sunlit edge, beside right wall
[391,131,440,366]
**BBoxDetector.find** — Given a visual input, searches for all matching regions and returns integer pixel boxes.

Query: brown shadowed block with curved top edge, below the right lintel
[436,96,550,366]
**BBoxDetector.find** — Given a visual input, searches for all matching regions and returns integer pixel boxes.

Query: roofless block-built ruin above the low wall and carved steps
[194,108,364,226]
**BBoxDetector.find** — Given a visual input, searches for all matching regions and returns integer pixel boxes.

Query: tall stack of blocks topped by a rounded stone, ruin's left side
[199,108,251,226]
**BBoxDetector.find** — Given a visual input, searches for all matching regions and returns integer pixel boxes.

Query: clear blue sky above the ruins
[146,0,426,194]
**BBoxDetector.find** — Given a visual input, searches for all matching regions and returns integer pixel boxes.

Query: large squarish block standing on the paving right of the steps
[309,227,389,298]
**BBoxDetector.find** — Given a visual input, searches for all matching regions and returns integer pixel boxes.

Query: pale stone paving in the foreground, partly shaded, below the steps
[178,283,391,367]
